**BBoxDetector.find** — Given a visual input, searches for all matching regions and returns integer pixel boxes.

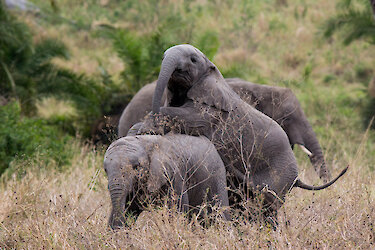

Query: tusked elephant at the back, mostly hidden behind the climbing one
[118,78,331,183]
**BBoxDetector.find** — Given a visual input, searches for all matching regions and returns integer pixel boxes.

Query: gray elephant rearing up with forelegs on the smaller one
[138,44,347,224]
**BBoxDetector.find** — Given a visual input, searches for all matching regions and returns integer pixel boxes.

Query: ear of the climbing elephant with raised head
[187,67,240,112]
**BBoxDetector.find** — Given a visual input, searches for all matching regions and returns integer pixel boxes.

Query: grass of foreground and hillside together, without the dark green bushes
[0,0,375,249]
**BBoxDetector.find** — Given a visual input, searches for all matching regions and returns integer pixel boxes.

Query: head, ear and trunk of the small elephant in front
[104,136,178,229]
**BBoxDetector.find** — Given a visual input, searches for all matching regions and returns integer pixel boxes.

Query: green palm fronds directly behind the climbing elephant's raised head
[100,25,219,94]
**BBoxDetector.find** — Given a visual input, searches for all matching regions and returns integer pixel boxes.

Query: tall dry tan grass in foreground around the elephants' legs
[0,131,375,249]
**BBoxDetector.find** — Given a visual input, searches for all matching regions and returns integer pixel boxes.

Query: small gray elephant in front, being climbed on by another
[104,134,230,229]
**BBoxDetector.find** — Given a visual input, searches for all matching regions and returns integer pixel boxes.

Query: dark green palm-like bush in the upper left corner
[0,2,98,115]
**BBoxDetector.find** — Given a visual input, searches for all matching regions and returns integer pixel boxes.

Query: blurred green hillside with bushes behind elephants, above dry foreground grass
[0,0,375,177]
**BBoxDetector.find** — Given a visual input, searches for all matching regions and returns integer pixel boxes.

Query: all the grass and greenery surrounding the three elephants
[0,0,375,246]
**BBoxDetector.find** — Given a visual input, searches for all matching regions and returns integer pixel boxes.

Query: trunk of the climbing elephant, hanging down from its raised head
[152,49,181,114]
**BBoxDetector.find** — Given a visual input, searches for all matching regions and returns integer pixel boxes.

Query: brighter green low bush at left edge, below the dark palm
[0,102,72,175]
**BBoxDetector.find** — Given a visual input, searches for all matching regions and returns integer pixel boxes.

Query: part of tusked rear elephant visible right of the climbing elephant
[226,78,331,183]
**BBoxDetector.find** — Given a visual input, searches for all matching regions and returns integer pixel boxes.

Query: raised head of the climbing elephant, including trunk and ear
[152,44,239,113]
